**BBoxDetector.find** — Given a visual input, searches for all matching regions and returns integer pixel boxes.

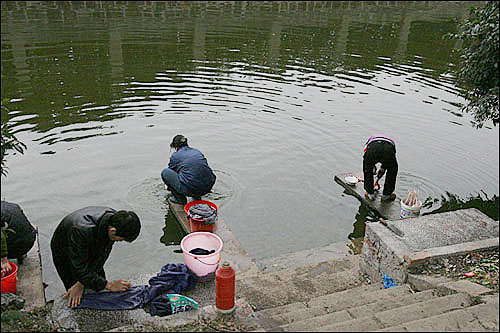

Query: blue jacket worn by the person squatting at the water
[168,146,216,194]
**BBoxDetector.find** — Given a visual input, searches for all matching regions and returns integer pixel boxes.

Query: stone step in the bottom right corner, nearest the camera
[375,294,499,332]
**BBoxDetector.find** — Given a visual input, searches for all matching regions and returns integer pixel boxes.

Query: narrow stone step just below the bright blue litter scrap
[278,288,439,332]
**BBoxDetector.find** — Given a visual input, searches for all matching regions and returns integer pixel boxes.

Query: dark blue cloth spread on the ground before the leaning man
[76,264,197,315]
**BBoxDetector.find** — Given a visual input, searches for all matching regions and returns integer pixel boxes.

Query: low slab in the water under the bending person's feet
[334,172,401,220]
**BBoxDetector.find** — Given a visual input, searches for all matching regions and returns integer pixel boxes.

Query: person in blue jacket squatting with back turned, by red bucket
[161,134,216,205]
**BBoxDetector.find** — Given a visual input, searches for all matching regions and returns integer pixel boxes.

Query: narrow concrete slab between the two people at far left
[16,226,46,311]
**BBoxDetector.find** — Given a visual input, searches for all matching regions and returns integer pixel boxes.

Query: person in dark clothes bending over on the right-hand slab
[363,134,398,200]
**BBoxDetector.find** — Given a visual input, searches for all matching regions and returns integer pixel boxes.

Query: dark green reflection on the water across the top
[2,1,476,139]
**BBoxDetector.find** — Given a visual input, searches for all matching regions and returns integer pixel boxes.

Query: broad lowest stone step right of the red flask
[236,256,362,311]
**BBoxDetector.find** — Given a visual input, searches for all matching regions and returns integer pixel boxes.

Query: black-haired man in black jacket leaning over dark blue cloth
[50,206,141,308]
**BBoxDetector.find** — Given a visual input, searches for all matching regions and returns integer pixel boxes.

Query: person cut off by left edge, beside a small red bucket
[1,201,37,276]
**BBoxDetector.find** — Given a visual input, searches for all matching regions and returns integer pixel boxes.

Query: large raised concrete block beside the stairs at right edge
[361,208,499,283]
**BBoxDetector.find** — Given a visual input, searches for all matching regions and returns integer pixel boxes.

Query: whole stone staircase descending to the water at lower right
[240,256,499,332]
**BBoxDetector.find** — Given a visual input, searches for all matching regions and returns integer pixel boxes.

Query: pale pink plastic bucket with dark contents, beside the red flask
[181,231,223,281]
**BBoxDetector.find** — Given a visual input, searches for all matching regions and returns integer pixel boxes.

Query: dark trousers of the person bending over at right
[363,141,398,195]
